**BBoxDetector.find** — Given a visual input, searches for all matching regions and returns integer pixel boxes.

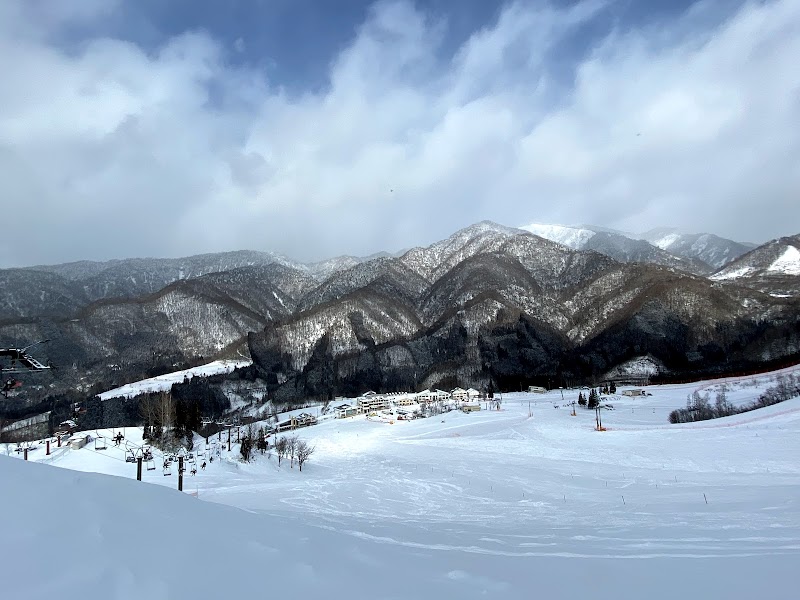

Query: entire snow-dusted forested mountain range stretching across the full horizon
[0,222,800,399]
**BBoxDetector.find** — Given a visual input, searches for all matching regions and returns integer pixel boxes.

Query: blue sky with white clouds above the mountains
[0,0,800,267]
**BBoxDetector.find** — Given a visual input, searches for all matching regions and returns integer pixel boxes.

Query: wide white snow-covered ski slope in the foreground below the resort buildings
[0,377,800,600]
